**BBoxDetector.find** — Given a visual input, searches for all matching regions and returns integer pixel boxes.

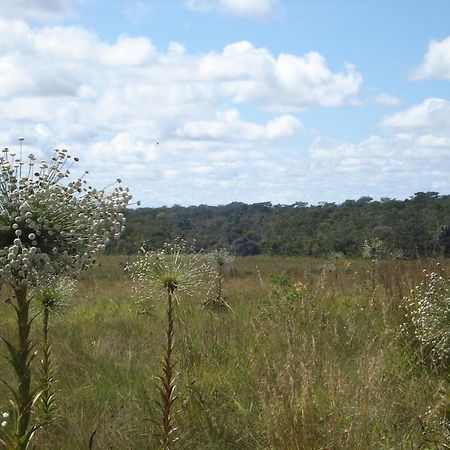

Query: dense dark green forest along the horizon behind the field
[108,192,450,258]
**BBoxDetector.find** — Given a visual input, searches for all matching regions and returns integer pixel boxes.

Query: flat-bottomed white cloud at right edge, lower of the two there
[380,98,450,134]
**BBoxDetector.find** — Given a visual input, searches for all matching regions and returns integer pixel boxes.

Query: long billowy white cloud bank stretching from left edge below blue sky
[0,20,361,139]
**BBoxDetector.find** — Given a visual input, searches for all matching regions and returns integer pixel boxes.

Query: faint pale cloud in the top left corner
[0,0,73,22]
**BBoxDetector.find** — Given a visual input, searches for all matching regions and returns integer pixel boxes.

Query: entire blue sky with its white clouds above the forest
[0,0,450,206]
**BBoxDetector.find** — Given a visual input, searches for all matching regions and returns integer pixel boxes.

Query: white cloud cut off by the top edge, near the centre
[185,0,282,20]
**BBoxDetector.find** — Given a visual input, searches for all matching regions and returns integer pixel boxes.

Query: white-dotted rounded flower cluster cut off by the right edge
[405,270,450,364]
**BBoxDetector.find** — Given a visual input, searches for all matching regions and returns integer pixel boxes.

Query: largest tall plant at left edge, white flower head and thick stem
[0,149,131,449]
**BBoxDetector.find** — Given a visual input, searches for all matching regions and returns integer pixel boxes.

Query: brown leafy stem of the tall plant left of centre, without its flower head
[158,286,177,450]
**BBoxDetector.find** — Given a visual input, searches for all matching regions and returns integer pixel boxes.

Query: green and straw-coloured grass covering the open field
[0,256,448,450]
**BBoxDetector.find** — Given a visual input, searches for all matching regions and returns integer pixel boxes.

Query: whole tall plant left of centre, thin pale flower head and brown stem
[127,240,208,450]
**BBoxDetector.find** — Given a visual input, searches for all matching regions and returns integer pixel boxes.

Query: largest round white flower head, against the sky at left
[0,149,131,286]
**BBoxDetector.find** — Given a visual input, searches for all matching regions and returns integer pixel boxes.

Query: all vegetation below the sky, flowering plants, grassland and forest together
[0,149,450,450]
